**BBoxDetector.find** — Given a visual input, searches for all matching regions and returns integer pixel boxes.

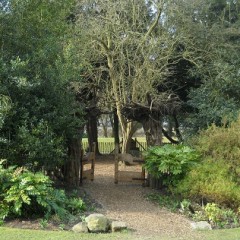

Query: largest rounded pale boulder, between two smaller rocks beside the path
[85,213,109,233]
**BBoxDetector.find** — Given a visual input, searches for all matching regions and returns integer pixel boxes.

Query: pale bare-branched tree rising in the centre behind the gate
[77,0,210,152]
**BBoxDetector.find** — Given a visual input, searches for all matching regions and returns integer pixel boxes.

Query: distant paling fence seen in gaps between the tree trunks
[82,137,147,154]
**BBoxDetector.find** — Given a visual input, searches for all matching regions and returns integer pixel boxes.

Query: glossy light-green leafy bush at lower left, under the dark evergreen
[0,161,85,220]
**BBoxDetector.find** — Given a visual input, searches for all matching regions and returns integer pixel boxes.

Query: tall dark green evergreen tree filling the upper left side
[0,0,83,185]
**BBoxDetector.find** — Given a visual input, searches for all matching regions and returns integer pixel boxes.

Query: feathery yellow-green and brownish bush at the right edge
[176,118,240,209]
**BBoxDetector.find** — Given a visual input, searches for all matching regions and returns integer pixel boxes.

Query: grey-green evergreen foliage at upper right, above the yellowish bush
[185,0,240,132]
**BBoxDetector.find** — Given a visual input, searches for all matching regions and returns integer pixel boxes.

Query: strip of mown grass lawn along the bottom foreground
[0,227,240,240]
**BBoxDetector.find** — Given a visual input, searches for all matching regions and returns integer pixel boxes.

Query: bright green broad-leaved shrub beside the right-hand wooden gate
[144,144,199,187]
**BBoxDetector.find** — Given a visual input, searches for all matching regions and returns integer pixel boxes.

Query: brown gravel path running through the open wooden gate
[83,156,200,240]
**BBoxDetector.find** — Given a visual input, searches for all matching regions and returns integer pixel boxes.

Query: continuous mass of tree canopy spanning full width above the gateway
[0,0,240,172]
